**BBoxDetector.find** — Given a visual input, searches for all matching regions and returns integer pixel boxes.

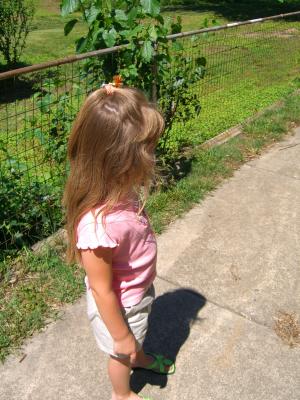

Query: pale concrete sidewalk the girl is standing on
[0,129,300,400]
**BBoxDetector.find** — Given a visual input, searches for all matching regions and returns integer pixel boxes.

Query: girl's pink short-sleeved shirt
[76,200,157,307]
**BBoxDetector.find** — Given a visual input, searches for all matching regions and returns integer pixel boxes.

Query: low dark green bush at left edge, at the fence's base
[0,160,61,257]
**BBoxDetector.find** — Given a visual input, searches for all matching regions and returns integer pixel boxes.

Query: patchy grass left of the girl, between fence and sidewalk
[0,242,84,361]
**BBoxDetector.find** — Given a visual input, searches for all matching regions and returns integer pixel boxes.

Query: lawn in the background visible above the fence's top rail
[10,0,300,64]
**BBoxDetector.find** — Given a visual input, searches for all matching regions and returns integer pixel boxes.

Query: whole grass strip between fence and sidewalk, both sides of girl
[0,93,300,361]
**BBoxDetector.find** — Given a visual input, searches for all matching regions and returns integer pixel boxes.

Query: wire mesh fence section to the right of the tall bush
[162,15,300,149]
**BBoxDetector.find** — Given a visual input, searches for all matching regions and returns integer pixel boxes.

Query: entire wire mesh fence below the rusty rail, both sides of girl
[0,12,300,257]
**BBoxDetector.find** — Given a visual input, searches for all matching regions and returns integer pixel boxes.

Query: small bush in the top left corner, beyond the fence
[0,0,34,67]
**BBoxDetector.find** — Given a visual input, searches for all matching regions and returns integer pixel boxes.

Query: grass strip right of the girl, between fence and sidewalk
[148,91,300,233]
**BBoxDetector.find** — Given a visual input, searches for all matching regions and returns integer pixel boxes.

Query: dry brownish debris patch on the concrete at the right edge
[274,311,300,347]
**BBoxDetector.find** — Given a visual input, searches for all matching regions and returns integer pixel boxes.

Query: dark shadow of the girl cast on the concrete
[130,289,206,393]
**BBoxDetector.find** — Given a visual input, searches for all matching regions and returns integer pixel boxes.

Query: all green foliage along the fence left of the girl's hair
[0,73,77,256]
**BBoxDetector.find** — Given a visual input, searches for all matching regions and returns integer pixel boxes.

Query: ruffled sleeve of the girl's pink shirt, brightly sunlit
[76,214,119,250]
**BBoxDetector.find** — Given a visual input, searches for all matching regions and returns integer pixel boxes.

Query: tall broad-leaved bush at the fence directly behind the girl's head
[61,0,206,164]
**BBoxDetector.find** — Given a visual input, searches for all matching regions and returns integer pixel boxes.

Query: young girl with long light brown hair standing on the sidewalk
[63,84,175,400]
